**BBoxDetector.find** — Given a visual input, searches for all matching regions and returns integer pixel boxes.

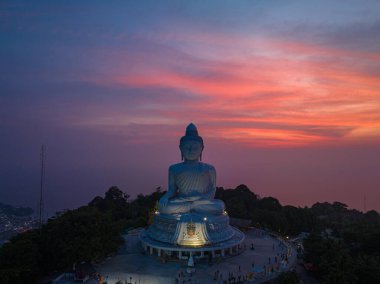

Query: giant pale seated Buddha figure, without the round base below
[158,123,224,216]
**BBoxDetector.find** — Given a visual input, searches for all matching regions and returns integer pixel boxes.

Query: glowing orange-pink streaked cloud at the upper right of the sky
[83,33,380,146]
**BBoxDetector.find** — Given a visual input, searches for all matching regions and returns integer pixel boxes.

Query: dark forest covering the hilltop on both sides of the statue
[0,185,380,284]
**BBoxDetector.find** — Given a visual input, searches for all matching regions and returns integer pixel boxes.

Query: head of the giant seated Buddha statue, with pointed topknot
[179,123,204,161]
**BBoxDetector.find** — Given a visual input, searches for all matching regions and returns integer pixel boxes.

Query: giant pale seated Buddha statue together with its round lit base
[140,123,244,252]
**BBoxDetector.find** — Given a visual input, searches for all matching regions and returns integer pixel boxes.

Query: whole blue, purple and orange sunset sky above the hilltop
[0,0,380,214]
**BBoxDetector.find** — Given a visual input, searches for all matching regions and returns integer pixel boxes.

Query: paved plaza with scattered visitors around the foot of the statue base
[96,230,296,284]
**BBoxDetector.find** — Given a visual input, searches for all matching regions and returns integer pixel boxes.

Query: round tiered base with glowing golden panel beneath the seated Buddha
[140,213,245,259]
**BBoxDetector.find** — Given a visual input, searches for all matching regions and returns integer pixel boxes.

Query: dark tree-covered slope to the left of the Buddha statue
[0,186,162,284]
